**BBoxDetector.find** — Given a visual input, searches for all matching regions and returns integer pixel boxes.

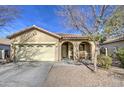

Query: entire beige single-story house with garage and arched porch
[8,26,94,61]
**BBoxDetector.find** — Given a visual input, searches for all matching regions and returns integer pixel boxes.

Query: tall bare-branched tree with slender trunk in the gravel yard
[59,5,116,71]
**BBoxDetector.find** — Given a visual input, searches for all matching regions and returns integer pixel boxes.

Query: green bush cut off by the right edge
[116,48,124,67]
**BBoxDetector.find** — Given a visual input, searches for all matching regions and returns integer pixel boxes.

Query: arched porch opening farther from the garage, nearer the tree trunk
[79,42,92,59]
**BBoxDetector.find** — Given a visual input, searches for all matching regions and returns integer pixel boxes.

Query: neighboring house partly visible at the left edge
[0,39,11,60]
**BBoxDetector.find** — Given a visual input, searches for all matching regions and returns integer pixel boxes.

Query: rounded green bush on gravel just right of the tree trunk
[97,55,112,69]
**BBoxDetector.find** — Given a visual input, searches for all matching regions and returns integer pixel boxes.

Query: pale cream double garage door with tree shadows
[17,44,55,61]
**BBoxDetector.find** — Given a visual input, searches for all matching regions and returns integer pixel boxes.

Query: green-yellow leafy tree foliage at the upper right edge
[105,6,124,37]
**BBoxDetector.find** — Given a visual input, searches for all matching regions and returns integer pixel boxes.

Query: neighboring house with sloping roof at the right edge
[101,36,124,55]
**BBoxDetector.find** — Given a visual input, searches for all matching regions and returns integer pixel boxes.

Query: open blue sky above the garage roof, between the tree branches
[0,5,77,38]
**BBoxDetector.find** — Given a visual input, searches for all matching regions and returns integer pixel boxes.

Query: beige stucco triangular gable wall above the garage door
[11,30,58,43]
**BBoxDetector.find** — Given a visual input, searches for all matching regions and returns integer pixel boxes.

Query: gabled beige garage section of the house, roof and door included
[9,26,61,61]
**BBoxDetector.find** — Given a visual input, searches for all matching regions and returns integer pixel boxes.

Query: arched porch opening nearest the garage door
[61,42,73,59]
